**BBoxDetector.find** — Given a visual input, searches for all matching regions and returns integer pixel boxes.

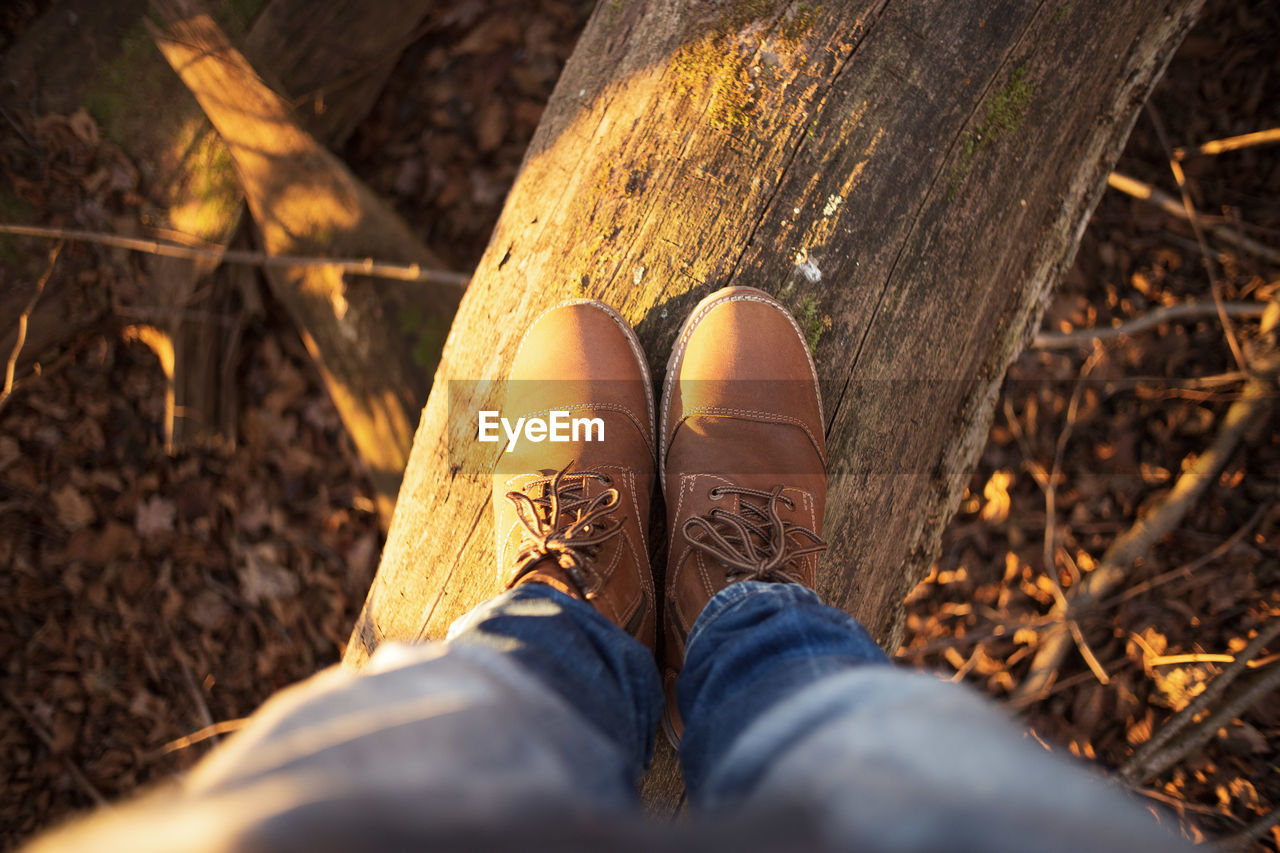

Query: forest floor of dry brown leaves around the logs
[0,0,1280,850]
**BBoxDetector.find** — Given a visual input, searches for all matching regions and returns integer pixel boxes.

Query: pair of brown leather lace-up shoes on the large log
[490,287,827,742]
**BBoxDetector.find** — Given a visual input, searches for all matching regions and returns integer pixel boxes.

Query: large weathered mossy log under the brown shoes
[346,0,1199,802]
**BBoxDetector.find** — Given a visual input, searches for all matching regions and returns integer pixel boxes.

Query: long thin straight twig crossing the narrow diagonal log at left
[0,223,471,287]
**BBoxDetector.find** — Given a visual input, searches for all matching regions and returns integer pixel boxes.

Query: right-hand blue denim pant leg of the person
[677,584,1188,853]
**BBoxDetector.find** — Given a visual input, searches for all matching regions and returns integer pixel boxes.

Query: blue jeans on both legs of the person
[20,583,1189,853]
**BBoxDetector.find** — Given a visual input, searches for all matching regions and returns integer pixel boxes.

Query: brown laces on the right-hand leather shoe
[681,485,827,583]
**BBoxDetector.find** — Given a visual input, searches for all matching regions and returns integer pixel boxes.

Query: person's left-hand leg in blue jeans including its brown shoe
[24,295,662,849]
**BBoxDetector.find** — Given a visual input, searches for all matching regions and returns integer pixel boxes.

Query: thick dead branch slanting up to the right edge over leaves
[1012,368,1271,704]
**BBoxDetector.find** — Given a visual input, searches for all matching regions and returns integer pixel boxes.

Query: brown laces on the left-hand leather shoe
[507,462,622,598]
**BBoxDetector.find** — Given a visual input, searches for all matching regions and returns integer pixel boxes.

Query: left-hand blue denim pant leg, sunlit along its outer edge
[26,585,662,853]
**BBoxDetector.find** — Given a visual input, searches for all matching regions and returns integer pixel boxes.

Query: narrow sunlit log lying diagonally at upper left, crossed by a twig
[151,0,461,517]
